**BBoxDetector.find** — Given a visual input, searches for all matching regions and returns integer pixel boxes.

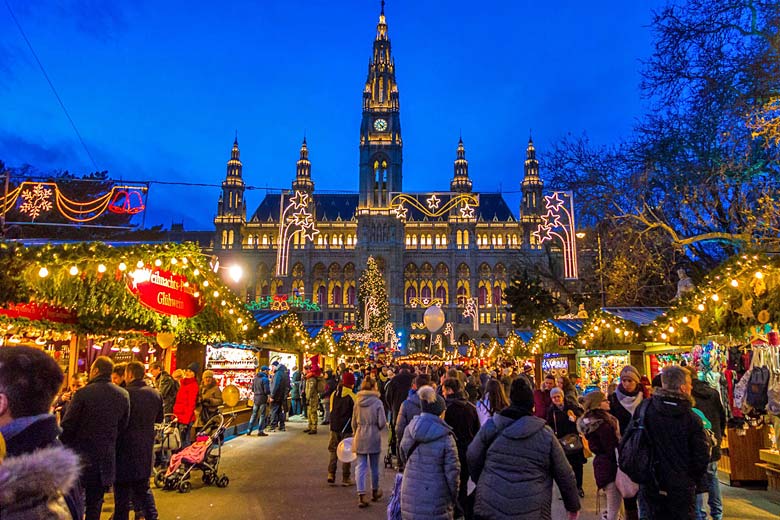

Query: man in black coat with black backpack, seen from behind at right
[620,366,711,520]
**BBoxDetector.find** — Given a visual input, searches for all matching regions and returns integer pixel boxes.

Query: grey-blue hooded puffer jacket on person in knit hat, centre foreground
[401,413,460,520]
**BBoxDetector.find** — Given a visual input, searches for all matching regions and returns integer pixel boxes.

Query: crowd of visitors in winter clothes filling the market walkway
[0,347,725,520]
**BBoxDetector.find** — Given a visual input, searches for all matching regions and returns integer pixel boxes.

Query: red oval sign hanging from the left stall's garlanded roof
[126,266,203,318]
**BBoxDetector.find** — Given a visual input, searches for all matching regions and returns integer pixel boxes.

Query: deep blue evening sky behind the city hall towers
[0,0,660,229]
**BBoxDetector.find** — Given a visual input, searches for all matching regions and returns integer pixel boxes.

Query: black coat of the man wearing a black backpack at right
[645,389,710,490]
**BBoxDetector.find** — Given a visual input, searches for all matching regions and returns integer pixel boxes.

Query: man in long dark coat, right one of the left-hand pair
[114,361,163,520]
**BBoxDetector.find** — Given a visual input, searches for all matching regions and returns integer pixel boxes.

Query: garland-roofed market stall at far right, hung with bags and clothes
[654,253,780,487]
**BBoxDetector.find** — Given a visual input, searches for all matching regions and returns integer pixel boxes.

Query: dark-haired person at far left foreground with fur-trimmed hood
[0,346,84,520]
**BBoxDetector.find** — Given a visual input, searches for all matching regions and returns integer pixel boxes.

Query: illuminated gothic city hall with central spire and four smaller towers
[213,7,544,343]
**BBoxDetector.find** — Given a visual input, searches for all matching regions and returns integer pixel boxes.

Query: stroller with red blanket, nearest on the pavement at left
[154,414,233,493]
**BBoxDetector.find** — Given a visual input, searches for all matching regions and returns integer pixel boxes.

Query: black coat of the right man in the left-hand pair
[116,379,163,482]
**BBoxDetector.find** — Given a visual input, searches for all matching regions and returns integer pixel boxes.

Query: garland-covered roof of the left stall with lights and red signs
[0,242,256,382]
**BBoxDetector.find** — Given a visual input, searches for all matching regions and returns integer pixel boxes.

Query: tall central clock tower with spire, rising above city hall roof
[358,2,403,209]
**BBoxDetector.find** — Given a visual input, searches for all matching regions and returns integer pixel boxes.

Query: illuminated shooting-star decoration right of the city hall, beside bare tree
[533,191,579,280]
